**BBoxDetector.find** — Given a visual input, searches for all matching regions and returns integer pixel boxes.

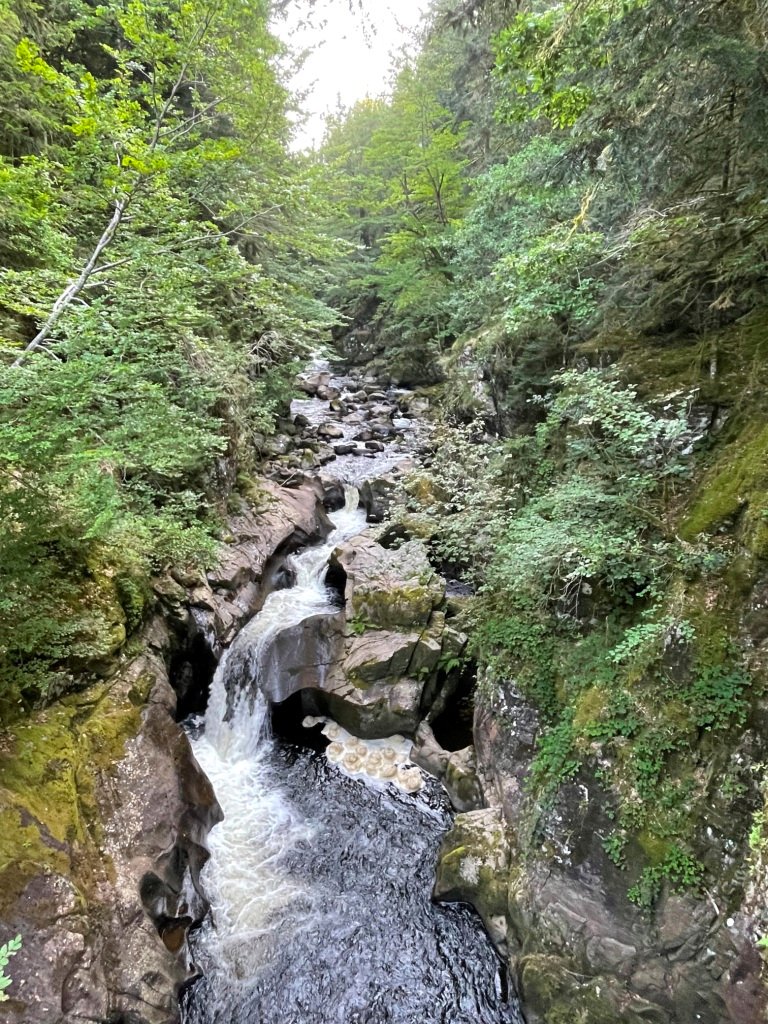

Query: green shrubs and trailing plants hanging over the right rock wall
[402,362,753,902]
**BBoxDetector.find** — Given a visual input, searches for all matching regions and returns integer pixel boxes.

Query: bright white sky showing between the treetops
[275,0,429,150]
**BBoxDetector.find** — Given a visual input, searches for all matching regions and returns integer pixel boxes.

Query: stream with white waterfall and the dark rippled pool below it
[182,364,521,1024]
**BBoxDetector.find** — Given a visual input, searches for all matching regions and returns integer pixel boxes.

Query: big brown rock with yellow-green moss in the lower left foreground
[0,624,220,1024]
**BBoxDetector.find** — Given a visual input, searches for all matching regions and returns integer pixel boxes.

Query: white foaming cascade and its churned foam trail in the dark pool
[191,487,366,978]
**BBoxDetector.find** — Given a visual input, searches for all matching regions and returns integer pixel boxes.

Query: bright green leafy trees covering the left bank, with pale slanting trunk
[0,0,337,707]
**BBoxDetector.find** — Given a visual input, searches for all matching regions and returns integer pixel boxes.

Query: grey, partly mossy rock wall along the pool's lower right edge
[435,686,766,1024]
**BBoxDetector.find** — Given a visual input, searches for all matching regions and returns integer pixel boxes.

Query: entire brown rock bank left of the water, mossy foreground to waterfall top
[0,481,331,1024]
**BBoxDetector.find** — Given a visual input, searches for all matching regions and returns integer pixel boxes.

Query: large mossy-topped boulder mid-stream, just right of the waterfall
[259,532,466,738]
